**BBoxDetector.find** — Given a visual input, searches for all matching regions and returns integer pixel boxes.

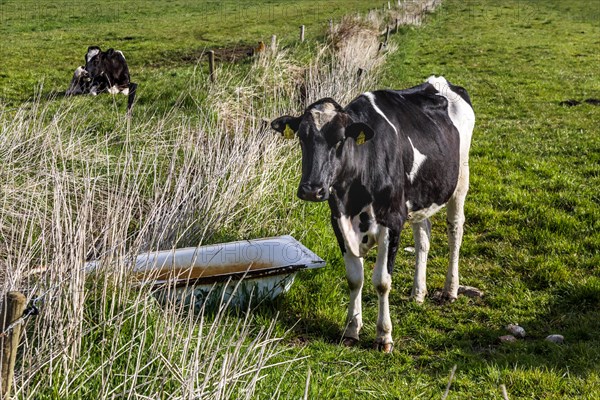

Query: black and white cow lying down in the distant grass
[65,46,137,113]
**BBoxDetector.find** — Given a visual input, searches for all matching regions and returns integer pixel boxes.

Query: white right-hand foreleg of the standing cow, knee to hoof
[373,226,393,350]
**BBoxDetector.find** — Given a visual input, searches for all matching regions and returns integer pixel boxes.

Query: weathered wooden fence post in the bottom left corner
[0,292,27,400]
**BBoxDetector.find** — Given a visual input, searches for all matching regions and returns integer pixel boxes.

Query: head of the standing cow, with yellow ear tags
[271,98,373,201]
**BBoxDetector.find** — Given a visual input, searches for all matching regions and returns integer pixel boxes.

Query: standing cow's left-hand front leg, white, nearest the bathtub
[344,252,364,340]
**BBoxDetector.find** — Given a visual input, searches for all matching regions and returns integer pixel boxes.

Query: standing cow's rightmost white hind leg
[442,167,469,301]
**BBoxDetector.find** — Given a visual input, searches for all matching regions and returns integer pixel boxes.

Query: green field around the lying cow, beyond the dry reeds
[0,0,372,105]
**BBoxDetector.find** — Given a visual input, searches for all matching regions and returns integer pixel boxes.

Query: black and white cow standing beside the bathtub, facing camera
[271,77,475,352]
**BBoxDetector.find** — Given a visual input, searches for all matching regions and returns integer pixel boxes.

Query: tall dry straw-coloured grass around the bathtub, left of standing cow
[0,1,440,399]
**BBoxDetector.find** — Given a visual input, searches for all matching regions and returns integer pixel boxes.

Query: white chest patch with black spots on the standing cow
[337,204,380,257]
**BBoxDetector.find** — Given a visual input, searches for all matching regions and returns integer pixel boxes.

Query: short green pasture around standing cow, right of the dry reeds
[272,0,600,398]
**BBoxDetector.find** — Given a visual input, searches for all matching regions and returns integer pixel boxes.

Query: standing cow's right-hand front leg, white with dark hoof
[373,226,400,353]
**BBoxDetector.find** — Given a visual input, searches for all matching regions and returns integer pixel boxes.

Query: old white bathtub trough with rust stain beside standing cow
[87,236,325,307]
